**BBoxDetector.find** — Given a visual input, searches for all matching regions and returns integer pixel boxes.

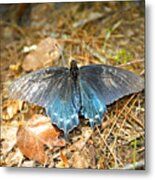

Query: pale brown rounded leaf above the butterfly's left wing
[22,37,61,71]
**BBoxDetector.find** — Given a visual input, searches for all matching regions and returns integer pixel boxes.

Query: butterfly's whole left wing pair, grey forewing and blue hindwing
[10,68,79,133]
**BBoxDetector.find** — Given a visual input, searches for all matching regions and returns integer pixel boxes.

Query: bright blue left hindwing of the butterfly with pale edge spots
[46,76,80,134]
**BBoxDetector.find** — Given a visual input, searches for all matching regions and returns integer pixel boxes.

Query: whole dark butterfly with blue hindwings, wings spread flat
[9,60,144,134]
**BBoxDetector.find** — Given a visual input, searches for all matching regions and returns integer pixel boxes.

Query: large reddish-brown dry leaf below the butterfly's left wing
[17,114,65,164]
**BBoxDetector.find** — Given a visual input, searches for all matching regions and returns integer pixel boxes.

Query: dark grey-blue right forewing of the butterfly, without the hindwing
[80,65,144,105]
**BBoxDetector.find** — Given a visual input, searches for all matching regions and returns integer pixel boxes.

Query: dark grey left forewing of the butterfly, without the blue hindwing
[10,68,68,107]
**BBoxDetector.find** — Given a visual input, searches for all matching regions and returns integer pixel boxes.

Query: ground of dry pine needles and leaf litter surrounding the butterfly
[0,1,145,169]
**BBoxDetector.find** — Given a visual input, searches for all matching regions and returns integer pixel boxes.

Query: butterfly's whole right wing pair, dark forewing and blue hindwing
[80,65,144,127]
